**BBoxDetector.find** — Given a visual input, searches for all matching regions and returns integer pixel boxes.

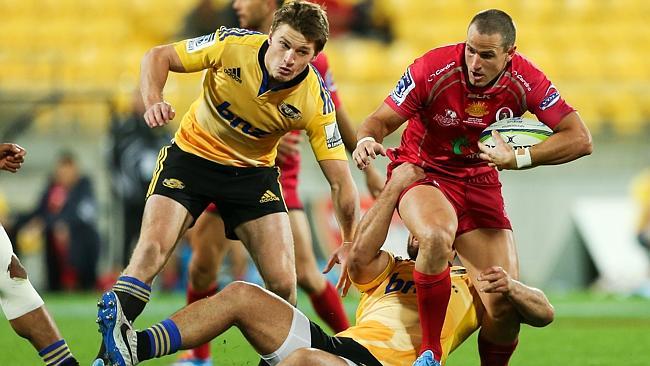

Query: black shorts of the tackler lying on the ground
[309,321,382,366]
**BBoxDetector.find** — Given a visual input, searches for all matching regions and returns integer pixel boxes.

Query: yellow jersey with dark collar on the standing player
[173,27,347,167]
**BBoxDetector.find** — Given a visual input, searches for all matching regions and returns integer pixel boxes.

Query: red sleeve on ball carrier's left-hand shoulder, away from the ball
[384,58,428,119]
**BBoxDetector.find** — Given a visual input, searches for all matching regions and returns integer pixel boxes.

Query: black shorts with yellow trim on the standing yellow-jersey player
[147,144,287,240]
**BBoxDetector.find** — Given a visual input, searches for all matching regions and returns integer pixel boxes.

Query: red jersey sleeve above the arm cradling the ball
[526,66,574,129]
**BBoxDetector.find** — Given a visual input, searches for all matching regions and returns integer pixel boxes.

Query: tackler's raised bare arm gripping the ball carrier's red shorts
[348,163,424,284]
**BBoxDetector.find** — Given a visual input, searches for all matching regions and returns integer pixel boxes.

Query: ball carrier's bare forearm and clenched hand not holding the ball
[352,103,406,170]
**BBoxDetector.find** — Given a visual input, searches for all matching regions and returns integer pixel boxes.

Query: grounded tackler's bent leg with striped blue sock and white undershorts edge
[104,281,296,365]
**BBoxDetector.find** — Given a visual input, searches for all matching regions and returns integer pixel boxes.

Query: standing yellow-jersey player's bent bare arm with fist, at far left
[140,45,185,127]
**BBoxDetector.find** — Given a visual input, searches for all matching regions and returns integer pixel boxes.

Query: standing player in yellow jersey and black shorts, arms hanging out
[97,1,358,365]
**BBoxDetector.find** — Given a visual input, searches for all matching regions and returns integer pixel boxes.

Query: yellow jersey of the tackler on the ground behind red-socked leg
[337,253,479,366]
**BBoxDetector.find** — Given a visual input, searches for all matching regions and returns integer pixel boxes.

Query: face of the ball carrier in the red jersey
[465,25,515,87]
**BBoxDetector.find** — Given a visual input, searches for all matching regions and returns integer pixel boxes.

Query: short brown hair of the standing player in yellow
[271,1,330,53]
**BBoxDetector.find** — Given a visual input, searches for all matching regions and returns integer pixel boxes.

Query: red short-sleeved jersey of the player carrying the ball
[384,43,574,178]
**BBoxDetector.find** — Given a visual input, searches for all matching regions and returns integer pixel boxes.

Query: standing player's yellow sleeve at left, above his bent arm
[173,27,227,72]
